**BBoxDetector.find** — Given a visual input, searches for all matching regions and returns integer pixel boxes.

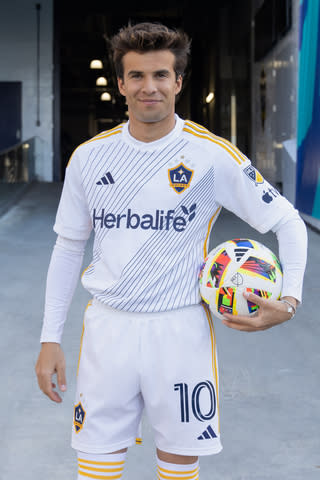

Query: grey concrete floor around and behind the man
[0,184,320,480]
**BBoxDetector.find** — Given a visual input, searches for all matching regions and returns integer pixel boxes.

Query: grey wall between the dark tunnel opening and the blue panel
[251,0,299,188]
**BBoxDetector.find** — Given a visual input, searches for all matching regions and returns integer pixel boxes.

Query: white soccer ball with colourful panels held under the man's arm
[199,238,282,318]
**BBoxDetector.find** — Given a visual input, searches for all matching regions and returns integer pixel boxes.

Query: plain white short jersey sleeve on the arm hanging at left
[53,150,92,240]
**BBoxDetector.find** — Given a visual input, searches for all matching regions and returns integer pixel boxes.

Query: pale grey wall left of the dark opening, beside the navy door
[0,0,53,181]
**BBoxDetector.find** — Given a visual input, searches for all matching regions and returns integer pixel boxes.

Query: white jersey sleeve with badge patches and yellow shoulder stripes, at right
[214,147,294,233]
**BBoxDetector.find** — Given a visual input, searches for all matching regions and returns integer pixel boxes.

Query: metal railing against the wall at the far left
[0,137,37,183]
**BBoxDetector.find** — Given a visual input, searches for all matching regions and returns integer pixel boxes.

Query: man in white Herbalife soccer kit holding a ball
[36,23,306,480]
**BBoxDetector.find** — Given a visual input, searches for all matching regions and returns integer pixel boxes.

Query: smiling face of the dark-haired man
[118,50,182,123]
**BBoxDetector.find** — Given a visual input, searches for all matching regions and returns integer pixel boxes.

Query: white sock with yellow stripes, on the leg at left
[78,452,127,480]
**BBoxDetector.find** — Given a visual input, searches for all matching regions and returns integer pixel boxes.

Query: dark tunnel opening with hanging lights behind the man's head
[54,0,276,179]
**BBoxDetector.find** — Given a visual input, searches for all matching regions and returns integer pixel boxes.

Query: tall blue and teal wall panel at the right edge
[296,0,320,219]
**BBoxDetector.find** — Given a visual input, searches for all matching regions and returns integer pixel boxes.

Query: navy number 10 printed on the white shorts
[174,380,216,422]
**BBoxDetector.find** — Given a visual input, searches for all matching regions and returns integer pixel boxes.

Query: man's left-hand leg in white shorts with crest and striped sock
[72,301,143,480]
